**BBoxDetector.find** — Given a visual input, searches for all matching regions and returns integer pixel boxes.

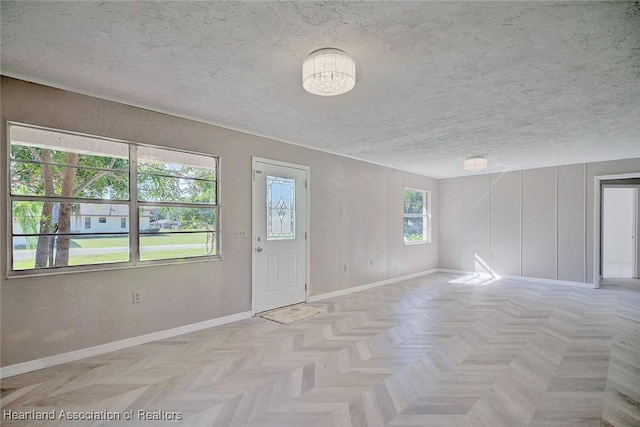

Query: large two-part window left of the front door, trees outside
[8,123,219,274]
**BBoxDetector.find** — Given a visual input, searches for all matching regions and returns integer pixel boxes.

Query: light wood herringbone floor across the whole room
[2,274,640,427]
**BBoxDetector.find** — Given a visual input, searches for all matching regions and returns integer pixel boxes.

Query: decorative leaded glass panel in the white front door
[267,176,296,240]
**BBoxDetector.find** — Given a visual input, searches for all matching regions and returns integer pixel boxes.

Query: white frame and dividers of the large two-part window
[5,121,222,278]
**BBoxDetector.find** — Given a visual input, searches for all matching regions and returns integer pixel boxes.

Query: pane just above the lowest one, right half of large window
[138,206,216,233]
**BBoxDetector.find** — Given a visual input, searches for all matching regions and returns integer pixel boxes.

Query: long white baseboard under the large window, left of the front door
[0,311,251,378]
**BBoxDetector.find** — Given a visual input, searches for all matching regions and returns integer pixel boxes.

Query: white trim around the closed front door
[251,156,311,316]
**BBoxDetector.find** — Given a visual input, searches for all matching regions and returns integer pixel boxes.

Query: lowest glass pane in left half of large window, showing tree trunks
[12,233,129,270]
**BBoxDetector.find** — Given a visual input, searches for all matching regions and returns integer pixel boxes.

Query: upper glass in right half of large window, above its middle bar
[138,147,216,204]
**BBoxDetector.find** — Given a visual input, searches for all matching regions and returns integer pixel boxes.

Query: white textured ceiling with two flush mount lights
[1,1,640,178]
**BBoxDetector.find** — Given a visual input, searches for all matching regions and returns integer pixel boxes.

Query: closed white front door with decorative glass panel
[252,158,308,313]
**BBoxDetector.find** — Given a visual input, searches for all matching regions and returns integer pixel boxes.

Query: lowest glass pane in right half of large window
[140,231,218,261]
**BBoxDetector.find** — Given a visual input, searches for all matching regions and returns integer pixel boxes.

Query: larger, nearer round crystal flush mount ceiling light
[302,48,356,96]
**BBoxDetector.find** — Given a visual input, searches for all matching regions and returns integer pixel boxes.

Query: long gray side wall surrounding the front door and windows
[0,77,439,366]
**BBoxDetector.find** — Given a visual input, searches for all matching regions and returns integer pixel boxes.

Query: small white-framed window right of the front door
[403,188,431,244]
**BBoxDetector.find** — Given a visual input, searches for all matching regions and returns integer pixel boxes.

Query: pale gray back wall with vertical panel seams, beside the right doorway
[438,158,640,283]
